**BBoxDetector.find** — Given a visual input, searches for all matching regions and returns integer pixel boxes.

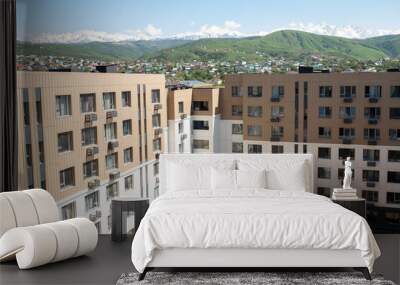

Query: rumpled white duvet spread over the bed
[132,189,380,272]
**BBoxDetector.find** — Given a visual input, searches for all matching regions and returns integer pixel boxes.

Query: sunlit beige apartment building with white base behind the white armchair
[17,72,168,233]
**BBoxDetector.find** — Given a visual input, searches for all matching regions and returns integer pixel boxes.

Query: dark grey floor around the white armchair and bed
[0,235,400,285]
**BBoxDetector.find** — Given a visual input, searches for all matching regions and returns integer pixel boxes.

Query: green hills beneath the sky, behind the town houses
[17,30,400,62]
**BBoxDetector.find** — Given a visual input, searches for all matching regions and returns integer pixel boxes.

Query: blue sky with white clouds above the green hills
[17,0,400,42]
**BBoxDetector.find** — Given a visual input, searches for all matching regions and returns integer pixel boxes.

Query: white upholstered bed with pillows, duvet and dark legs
[132,154,380,279]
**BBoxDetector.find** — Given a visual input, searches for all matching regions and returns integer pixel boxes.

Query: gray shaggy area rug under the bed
[117,272,395,285]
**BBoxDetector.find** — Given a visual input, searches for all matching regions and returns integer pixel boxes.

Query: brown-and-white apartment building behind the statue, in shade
[218,72,400,231]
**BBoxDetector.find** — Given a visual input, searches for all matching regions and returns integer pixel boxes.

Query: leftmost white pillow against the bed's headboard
[167,163,211,191]
